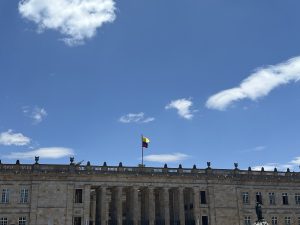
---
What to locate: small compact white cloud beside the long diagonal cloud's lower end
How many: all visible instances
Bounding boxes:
[165,98,194,120]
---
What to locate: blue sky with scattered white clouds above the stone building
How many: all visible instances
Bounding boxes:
[0,0,300,171]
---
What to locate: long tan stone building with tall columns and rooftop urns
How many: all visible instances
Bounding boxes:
[0,161,300,225]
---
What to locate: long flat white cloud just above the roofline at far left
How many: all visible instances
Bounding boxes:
[2,147,74,159]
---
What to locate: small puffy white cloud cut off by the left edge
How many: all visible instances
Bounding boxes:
[0,130,31,146]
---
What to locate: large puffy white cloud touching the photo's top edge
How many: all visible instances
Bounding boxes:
[19,0,116,46]
